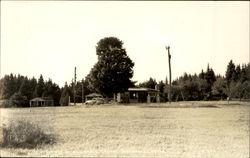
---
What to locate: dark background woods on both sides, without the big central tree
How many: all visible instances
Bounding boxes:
[0,60,250,107]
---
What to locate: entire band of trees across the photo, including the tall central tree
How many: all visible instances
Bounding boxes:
[0,37,250,106]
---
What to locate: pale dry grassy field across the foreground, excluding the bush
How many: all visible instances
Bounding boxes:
[0,102,250,158]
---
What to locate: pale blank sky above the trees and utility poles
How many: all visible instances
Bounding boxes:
[1,1,249,86]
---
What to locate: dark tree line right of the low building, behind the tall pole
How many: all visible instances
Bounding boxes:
[137,60,250,101]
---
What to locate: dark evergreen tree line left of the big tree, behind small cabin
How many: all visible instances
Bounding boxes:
[0,73,94,107]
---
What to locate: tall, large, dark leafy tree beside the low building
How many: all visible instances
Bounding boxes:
[86,37,134,96]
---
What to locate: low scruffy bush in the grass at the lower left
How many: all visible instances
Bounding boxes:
[1,121,55,148]
